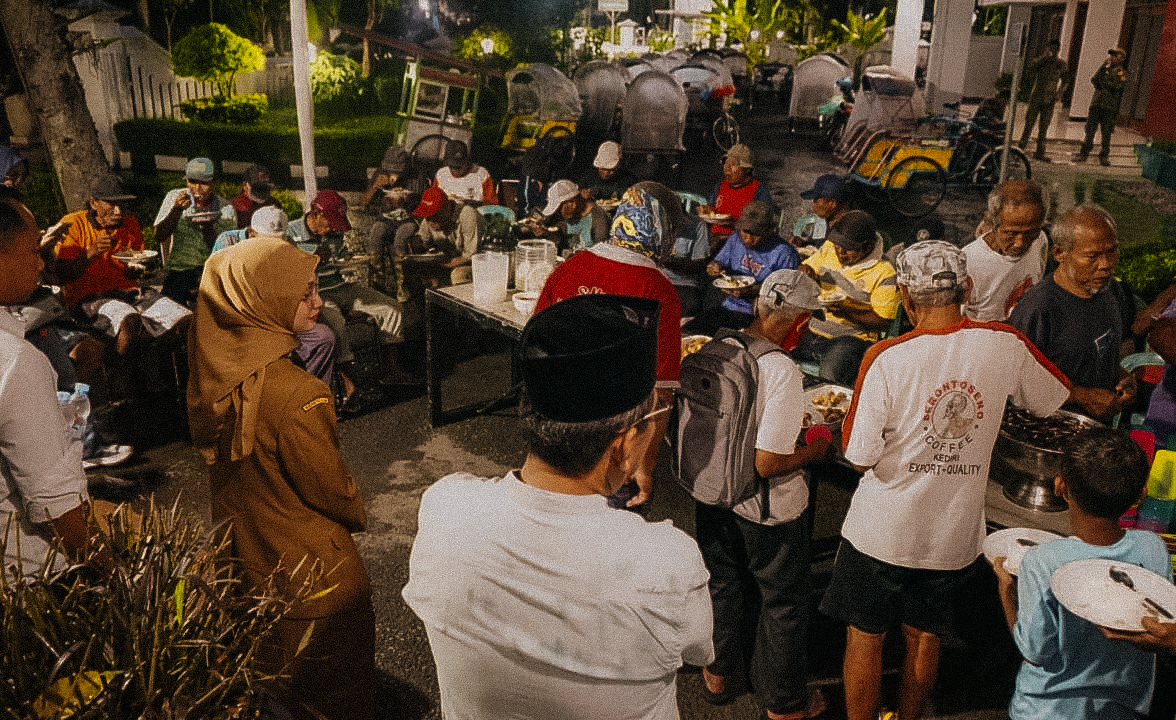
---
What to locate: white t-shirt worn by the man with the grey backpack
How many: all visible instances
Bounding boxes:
[728,340,808,525]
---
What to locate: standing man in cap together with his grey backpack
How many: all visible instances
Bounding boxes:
[675,269,831,720]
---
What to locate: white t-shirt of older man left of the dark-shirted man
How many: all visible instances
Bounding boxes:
[963,233,1049,322]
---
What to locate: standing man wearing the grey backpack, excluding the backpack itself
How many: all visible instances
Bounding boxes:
[695,269,829,720]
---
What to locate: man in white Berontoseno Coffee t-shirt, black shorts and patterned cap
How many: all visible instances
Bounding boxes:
[821,241,1070,720]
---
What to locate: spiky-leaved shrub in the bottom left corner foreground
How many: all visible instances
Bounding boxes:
[0,502,322,720]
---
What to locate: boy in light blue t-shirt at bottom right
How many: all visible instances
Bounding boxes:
[994,428,1171,720]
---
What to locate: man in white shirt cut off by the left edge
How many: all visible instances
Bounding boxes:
[0,198,89,576]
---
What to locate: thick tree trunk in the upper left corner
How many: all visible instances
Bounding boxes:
[0,0,111,211]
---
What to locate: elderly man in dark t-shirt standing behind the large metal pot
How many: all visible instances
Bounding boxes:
[1009,205,1136,420]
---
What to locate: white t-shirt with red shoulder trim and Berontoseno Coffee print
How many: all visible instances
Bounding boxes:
[841,320,1069,571]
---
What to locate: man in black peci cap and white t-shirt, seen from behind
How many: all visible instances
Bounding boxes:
[403,295,714,720]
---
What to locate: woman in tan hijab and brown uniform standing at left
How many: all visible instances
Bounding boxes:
[188,238,375,720]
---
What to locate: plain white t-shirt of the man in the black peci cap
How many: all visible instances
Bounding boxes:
[403,473,714,720]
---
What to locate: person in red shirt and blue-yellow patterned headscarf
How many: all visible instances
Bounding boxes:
[535,189,682,507]
